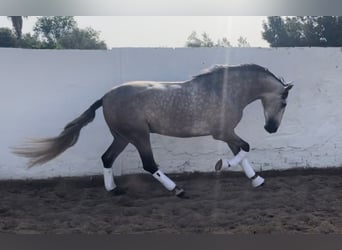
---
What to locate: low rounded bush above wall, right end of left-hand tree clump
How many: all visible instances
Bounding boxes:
[58,28,107,49]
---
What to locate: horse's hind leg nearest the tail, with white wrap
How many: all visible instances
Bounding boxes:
[101,136,128,195]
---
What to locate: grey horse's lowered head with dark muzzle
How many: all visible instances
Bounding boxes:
[261,83,293,133]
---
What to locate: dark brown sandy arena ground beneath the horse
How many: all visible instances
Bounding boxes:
[0,168,342,234]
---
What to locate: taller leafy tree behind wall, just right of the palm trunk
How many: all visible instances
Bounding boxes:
[33,16,76,48]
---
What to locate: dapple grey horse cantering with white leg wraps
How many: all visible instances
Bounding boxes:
[14,64,293,197]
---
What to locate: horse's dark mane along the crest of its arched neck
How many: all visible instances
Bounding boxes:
[193,64,285,85]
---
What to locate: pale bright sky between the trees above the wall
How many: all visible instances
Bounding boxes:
[0,16,268,48]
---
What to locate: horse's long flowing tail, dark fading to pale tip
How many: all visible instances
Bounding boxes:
[13,99,102,167]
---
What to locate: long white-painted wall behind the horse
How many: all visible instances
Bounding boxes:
[0,48,342,179]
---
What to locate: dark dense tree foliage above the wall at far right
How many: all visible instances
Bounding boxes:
[262,16,342,47]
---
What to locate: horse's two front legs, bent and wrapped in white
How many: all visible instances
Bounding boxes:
[215,134,265,187]
